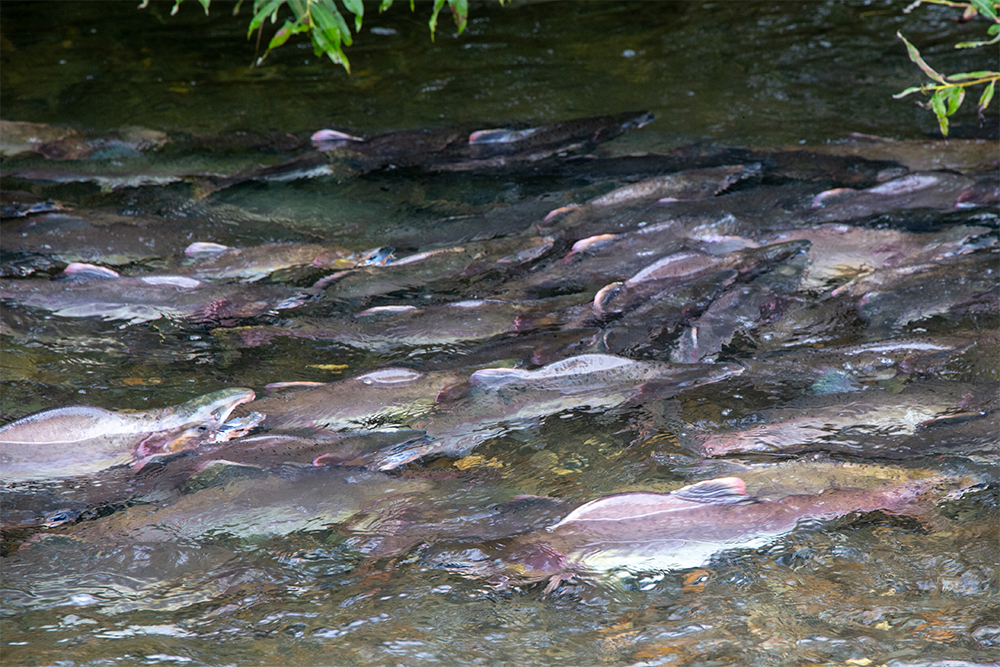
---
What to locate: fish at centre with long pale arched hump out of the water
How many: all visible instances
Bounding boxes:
[357,354,743,470]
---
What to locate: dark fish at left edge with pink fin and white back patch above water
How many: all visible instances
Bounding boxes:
[0,262,316,325]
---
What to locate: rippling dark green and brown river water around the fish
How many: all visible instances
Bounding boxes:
[0,0,1000,666]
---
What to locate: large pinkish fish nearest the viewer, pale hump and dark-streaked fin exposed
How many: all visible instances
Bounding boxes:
[437,475,954,592]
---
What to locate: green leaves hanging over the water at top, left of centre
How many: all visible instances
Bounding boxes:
[146,0,504,73]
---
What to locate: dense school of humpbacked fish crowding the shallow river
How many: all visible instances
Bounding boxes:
[0,113,1000,593]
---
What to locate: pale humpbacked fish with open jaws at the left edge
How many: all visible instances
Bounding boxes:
[0,388,254,484]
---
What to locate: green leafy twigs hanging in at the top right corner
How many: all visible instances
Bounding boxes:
[893,0,1000,137]
